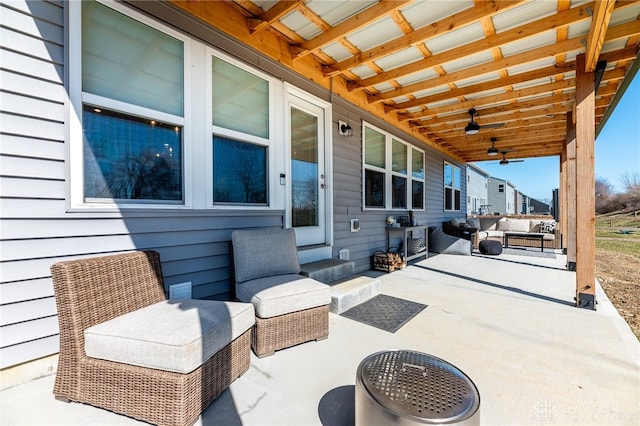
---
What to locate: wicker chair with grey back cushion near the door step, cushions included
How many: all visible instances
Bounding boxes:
[231,228,331,357]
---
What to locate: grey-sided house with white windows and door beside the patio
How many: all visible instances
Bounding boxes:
[0,1,470,376]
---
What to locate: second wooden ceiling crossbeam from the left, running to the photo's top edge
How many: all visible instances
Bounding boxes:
[290,0,413,60]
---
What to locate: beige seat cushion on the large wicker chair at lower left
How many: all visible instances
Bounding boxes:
[84,299,255,373]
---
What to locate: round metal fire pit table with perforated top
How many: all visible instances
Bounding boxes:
[355,350,480,426]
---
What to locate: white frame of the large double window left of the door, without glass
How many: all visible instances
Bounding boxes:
[65,0,285,212]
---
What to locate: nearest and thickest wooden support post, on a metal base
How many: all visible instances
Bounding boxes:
[576,54,596,310]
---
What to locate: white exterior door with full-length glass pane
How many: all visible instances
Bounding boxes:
[287,94,327,246]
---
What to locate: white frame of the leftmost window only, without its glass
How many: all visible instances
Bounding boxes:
[66,0,192,211]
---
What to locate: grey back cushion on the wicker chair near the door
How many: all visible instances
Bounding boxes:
[231,228,300,283]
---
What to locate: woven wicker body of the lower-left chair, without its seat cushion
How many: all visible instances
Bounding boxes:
[51,251,254,425]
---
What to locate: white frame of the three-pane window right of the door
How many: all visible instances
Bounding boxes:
[362,121,426,211]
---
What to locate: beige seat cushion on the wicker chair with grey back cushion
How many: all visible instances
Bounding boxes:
[236,274,331,318]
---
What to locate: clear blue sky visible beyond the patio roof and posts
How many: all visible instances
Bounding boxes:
[475,72,640,201]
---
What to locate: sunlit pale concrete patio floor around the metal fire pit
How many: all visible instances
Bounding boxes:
[0,254,640,426]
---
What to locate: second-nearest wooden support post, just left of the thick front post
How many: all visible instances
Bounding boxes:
[565,112,578,271]
